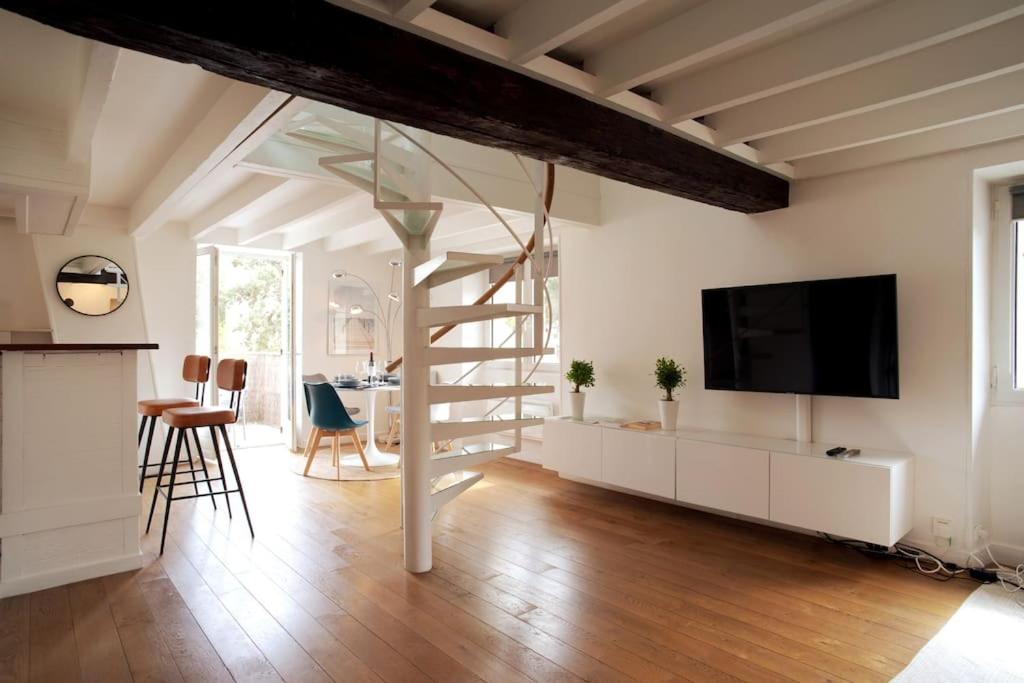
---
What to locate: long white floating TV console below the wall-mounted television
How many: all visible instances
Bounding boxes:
[544,418,913,546]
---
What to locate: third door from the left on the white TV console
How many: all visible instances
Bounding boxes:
[676,439,769,519]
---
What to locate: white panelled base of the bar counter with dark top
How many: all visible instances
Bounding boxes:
[0,349,142,597]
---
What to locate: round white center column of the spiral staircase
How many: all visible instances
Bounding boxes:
[401,234,433,573]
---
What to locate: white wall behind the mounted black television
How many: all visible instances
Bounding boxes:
[560,136,1024,548]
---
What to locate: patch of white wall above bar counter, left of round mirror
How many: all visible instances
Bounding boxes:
[0,228,53,331]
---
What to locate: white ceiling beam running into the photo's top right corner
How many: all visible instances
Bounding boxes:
[654,0,1024,123]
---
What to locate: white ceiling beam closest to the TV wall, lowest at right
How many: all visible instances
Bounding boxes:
[794,110,1024,178]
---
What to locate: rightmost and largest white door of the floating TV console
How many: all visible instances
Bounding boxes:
[771,453,899,546]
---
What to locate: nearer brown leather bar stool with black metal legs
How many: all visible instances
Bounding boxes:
[145,358,256,555]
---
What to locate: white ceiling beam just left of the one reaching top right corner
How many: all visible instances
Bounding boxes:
[584,0,852,96]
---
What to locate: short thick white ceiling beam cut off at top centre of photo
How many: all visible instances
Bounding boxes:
[495,0,644,65]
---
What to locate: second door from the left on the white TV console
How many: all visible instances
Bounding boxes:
[601,429,676,498]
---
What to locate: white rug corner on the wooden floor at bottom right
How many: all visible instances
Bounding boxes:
[893,584,1024,683]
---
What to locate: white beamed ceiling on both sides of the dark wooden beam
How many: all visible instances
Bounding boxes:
[8,0,1024,242]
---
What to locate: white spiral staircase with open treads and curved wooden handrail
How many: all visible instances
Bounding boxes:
[283,110,554,572]
